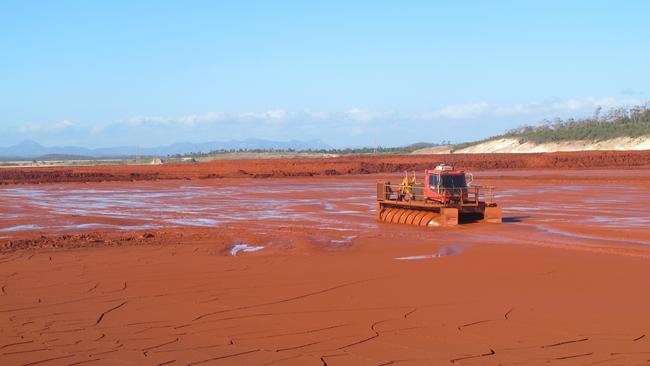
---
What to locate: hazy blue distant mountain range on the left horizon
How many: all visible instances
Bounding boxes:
[0,138,330,160]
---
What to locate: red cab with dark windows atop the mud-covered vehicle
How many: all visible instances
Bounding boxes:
[424,164,472,203]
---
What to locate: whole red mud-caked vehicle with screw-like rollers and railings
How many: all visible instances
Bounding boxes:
[377,164,501,226]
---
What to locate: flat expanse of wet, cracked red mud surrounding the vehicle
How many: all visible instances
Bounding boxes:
[0,164,650,365]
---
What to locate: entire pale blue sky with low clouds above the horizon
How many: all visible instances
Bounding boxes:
[0,0,650,147]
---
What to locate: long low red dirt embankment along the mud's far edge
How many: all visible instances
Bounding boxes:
[0,151,650,185]
